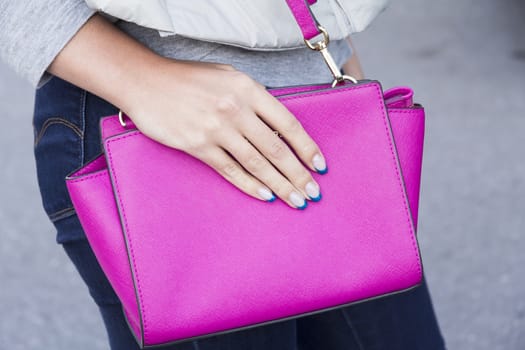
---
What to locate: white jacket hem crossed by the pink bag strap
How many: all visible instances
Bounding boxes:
[86,0,388,50]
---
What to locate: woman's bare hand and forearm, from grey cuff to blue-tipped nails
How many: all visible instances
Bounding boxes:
[49,15,326,209]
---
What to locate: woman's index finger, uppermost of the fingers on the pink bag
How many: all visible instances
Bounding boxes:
[252,89,327,174]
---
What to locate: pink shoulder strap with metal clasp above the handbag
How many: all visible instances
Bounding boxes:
[286,0,357,87]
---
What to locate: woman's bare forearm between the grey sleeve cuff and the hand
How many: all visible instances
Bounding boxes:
[48,15,170,110]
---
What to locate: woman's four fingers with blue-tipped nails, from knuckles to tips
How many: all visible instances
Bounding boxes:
[183,76,326,209]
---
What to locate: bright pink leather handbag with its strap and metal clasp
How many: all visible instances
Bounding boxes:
[66,0,424,348]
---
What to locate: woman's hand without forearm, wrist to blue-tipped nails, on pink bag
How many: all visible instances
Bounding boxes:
[124,60,324,208]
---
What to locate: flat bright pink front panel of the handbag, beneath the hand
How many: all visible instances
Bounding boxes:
[101,83,421,345]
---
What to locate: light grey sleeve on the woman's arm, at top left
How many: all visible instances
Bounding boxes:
[0,0,96,88]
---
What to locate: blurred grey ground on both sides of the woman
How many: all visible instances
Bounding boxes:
[0,0,525,350]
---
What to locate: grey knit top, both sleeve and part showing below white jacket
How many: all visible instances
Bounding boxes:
[0,0,352,88]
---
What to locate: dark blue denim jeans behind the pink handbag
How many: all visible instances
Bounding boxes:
[33,77,445,350]
